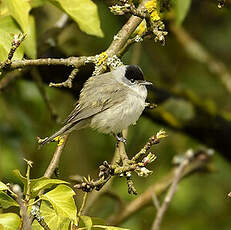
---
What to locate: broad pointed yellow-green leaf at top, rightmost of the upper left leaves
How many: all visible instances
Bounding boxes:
[50,0,104,37]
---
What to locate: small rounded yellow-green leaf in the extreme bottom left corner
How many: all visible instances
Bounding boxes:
[0,213,20,230]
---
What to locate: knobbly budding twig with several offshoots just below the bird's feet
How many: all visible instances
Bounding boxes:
[74,130,161,194]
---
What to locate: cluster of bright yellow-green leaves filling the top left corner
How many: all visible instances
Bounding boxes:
[0,0,103,61]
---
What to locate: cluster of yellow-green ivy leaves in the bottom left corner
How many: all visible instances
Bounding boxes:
[0,165,128,230]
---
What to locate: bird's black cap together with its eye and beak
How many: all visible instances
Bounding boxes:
[125,65,152,85]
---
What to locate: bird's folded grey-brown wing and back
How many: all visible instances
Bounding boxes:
[65,73,128,124]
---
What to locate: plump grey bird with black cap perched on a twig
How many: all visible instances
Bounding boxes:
[39,65,152,145]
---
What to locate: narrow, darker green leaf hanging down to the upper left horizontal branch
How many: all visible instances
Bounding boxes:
[23,16,37,59]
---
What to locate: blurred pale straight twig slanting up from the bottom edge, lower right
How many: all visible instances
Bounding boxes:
[151,150,193,230]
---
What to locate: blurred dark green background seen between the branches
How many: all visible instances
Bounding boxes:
[0,0,231,230]
